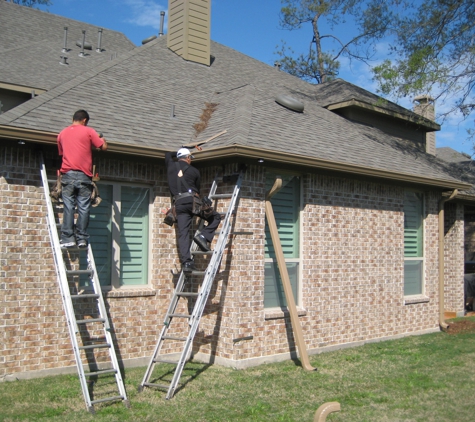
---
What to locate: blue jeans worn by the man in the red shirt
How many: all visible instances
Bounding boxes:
[61,170,92,243]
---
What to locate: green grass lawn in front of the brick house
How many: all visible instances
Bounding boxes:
[0,333,475,422]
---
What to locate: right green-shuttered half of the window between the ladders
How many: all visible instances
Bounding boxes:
[120,186,149,286]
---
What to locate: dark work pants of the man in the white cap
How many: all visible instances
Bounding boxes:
[175,197,221,264]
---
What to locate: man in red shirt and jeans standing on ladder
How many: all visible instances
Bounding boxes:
[58,110,107,248]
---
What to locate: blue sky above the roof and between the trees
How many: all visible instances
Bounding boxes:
[35,0,474,154]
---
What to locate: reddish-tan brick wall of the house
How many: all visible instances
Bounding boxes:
[0,145,463,377]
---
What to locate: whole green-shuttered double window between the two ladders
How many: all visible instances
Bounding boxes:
[81,183,150,288]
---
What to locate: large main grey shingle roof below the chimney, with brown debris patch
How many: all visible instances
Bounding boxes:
[0,3,468,189]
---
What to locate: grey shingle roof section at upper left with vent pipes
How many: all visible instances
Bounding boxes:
[0,0,135,90]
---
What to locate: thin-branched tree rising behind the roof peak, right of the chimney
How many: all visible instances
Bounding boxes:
[276,0,391,83]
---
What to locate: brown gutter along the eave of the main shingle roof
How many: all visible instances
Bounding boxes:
[0,125,472,190]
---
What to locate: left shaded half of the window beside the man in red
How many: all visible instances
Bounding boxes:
[81,184,112,286]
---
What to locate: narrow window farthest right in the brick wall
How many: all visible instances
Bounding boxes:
[404,191,424,296]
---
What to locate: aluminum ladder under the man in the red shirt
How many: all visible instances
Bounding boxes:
[40,155,130,414]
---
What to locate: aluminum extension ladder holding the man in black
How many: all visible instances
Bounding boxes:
[138,169,244,399]
